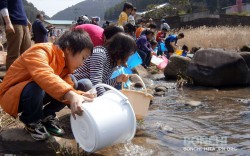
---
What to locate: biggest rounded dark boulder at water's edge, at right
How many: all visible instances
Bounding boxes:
[187,49,249,87]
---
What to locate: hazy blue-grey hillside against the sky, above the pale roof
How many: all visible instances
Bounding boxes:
[52,0,122,20]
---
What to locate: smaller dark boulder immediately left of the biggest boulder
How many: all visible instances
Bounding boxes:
[164,55,191,79]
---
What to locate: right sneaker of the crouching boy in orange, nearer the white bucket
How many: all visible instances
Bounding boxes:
[42,115,65,136]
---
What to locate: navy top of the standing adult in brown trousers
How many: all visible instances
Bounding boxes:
[0,0,28,26]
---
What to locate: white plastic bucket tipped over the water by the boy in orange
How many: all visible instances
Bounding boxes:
[71,84,136,152]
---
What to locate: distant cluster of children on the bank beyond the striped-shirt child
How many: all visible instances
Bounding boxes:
[117,2,188,68]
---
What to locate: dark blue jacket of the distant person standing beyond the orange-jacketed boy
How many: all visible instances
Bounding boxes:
[32,19,48,43]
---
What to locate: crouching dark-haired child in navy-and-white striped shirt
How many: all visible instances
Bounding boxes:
[73,33,136,96]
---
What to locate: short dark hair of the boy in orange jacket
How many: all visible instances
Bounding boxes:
[54,29,93,56]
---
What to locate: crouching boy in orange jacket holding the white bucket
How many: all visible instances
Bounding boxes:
[0,30,94,140]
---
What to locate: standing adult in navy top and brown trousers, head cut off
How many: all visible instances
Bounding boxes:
[0,0,31,70]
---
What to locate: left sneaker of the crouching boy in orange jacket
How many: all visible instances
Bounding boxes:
[25,121,50,141]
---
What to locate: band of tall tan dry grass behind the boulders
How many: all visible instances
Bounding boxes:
[176,26,250,51]
